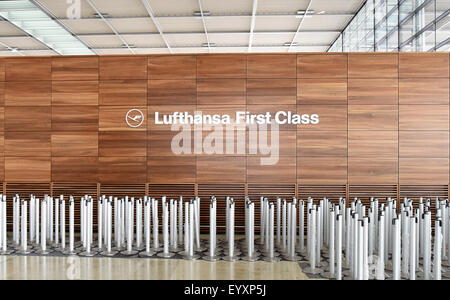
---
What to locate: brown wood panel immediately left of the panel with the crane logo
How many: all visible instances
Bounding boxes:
[52,105,98,131]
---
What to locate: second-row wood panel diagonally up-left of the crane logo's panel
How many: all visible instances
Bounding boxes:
[52,81,98,105]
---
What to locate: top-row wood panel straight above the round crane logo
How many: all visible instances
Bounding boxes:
[99,56,147,80]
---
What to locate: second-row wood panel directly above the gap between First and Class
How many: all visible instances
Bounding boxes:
[247,79,297,104]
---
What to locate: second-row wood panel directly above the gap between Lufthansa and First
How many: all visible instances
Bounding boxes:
[197,79,246,105]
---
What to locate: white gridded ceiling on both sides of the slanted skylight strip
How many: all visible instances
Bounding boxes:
[0,0,365,56]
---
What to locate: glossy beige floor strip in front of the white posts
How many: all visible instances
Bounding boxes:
[0,256,308,280]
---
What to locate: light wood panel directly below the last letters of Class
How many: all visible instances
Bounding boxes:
[297,131,347,156]
